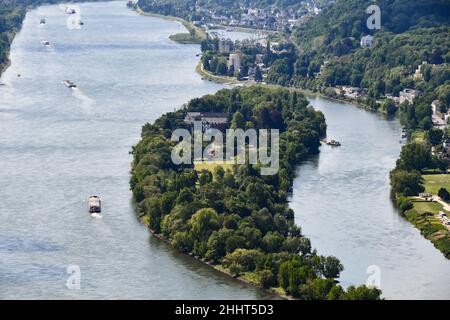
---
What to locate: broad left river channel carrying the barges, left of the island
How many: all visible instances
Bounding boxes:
[0,2,271,299]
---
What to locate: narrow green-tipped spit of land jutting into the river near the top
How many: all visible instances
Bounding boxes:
[134,5,206,44]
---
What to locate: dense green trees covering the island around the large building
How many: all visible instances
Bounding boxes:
[130,86,380,299]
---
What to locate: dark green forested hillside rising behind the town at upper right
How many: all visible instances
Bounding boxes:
[293,0,450,98]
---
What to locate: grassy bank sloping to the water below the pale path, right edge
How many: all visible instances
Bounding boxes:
[404,199,450,259]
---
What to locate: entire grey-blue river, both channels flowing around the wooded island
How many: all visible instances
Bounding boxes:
[0,2,450,299]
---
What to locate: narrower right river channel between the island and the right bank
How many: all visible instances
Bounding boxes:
[291,97,450,299]
